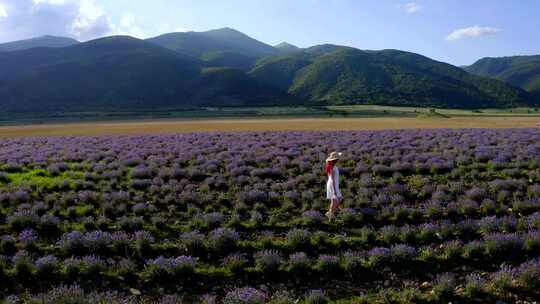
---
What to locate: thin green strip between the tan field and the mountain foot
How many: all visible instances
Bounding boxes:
[4,105,540,126]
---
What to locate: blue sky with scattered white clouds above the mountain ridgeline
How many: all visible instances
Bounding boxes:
[0,0,540,65]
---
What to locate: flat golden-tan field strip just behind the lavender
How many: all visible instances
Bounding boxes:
[0,115,540,137]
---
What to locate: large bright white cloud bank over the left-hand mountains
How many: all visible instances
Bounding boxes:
[0,0,190,42]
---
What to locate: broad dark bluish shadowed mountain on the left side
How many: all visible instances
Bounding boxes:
[0,36,296,111]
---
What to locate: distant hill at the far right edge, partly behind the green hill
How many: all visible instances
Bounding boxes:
[464,55,540,96]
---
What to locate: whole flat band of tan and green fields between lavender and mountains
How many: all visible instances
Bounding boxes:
[0,105,540,137]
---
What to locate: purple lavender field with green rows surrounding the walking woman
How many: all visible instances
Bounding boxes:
[0,129,540,304]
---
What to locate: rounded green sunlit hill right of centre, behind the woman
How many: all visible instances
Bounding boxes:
[250,45,530,108]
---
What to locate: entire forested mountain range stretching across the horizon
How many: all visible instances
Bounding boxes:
[0,28,539,112]
